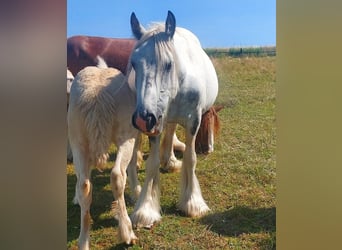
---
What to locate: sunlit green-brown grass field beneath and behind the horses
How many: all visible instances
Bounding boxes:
[67,54,276,249]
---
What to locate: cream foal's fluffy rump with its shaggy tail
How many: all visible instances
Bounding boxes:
[68,66,135,155]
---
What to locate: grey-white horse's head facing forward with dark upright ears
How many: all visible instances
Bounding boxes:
[130,11,178,135]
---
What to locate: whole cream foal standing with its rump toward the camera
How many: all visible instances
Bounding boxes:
[68,67,140,249]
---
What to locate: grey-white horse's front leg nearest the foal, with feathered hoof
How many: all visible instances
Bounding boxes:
[131,135,161,228]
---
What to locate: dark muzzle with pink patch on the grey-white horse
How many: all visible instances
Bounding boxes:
[132,111,160,136]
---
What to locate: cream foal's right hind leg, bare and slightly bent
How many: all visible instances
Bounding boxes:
[110,139,138,244]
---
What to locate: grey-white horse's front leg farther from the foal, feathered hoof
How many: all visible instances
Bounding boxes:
[179,115,210,217]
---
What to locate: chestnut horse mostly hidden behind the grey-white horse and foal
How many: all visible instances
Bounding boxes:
[67,36,219,155]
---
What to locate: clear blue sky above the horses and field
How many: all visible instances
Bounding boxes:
[67,0,276,48]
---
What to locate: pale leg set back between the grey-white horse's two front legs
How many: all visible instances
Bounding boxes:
[160,123,185,172]
